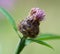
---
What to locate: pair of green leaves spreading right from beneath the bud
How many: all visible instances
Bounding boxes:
[28,34,60,49]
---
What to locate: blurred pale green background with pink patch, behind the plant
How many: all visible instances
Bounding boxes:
[0,0,60,54]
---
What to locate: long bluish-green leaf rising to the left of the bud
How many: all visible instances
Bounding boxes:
[0,7,21,38]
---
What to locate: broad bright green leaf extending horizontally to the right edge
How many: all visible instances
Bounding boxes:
[36,34,60,40]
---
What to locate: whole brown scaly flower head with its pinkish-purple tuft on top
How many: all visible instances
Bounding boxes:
[18,8,45,38]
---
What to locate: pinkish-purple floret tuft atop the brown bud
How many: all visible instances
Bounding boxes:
[30,8,45,21]
